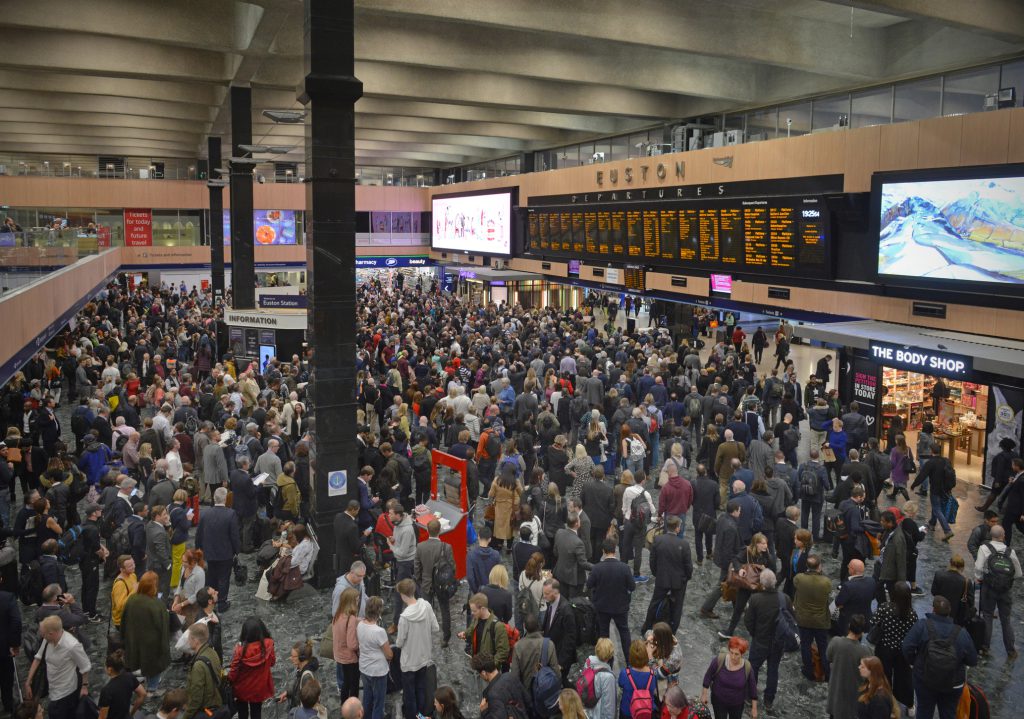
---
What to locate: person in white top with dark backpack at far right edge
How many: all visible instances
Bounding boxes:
[974,524,1022,660]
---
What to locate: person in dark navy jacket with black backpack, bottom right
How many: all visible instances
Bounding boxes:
[901,597,978,719]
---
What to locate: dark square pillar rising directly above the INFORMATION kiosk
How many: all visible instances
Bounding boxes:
[230,86,256,309]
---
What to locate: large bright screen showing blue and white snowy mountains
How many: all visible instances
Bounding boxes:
[879,177,1024,284]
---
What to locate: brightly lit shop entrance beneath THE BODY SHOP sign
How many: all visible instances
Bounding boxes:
[882,367,989,484]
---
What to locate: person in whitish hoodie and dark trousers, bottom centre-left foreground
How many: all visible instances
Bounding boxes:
[394,578,440,719]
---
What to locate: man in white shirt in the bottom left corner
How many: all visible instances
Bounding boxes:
[24,615,92,719]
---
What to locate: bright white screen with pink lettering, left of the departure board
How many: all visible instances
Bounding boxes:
[430,187,516,257]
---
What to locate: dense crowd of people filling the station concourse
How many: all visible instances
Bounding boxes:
[0,281,1024,719]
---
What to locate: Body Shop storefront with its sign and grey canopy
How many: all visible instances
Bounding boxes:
[805,322,1024,484]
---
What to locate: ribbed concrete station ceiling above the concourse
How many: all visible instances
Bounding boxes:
[0,0,1024,167]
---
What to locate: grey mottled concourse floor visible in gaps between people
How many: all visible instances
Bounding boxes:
[22,305,1024,719]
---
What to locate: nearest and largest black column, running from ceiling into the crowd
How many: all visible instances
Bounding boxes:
[300,0,362,585]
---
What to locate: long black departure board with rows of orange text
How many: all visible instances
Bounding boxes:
[527,197,830,278]
